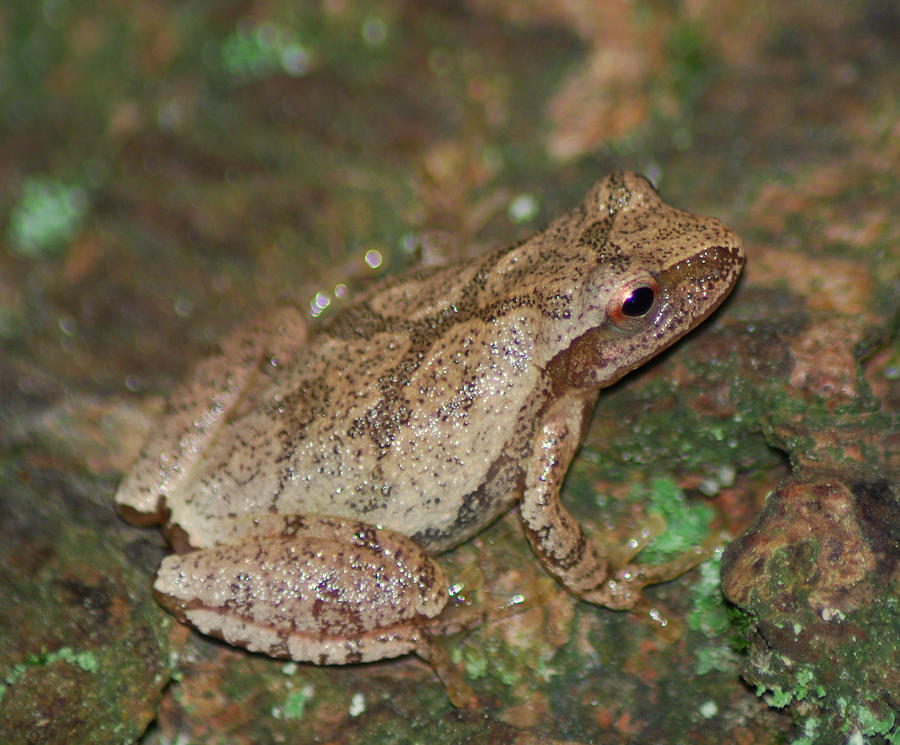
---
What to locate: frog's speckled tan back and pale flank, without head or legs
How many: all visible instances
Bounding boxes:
[179,247,568,550]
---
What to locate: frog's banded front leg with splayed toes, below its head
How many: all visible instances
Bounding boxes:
[520,396,704,610]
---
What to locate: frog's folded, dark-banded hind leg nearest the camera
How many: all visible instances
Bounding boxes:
[154,515,447,664]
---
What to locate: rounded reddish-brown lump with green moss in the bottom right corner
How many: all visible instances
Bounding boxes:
[722,472,900,743]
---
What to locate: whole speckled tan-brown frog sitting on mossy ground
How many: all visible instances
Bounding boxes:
[115,172,745,706]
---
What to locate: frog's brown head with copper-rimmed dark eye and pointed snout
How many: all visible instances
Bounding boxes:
[549,173,744,389]
